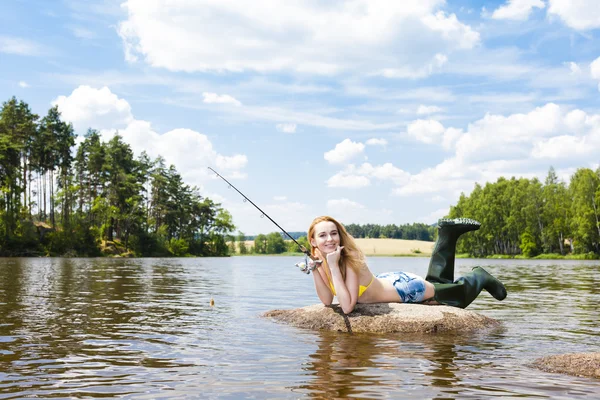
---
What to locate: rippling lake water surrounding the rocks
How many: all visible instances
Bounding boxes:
[0,257,600,399]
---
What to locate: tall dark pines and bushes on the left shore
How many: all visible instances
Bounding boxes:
[0,97,235,256]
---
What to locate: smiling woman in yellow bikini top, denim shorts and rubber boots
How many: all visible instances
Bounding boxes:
[308,216,506,314]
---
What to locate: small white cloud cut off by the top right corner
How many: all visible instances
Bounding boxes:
[548,0,600,31]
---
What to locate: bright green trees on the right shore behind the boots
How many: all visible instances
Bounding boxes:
[449,167,600,258]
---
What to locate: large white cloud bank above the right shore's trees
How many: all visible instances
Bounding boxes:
[393,103,600,199]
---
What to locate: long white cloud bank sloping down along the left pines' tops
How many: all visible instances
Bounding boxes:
[53,86,248,184]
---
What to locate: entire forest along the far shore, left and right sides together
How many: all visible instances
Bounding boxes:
[0,97,600,258]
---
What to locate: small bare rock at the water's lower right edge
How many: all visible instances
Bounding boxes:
[531,352,600,379]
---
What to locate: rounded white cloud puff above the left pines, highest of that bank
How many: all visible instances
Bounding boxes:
[52,85,133,133]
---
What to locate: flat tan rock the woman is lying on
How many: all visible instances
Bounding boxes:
[263,303,499,333]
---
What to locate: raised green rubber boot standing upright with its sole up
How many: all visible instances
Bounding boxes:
[425,218,481,283]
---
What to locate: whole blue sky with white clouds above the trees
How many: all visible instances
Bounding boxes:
[0,0,600,235]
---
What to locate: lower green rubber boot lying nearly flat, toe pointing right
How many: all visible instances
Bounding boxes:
[433,267,507,308]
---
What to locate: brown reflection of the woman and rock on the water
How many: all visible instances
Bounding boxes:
[299,332,502,399]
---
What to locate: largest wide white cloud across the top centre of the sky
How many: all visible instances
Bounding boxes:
[118,0,480,75]
